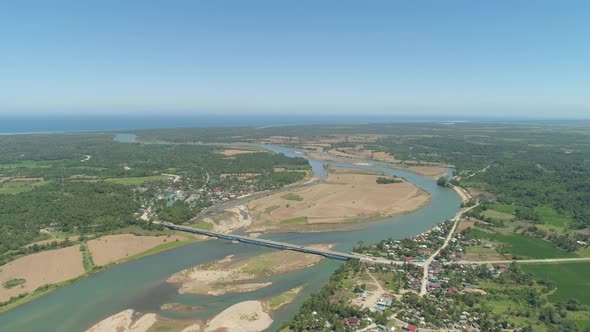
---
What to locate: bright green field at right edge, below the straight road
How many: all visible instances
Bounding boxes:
[521,262,590,306]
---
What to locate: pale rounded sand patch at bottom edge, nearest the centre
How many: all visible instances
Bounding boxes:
[205,301,273,332]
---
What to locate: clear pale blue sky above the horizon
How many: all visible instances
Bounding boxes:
[0,0,590,118]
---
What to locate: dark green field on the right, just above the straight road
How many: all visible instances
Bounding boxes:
[478,228,578,259]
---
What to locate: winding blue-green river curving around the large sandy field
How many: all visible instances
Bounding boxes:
[0,137,460,331]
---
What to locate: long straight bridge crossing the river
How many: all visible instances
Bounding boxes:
[162,222,402,264]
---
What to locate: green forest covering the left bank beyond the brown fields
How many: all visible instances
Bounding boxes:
[0,133,309,265]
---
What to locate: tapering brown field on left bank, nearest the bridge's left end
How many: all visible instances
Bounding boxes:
[88,234,185,266]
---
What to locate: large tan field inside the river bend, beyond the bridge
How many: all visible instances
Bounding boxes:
[248,168,430,231]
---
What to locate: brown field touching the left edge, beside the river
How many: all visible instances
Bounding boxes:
[0,245,85,302]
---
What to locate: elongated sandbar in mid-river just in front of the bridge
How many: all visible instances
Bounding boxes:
[168,245,332,296]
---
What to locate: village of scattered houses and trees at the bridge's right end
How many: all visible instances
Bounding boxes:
[328,217,526,331]
